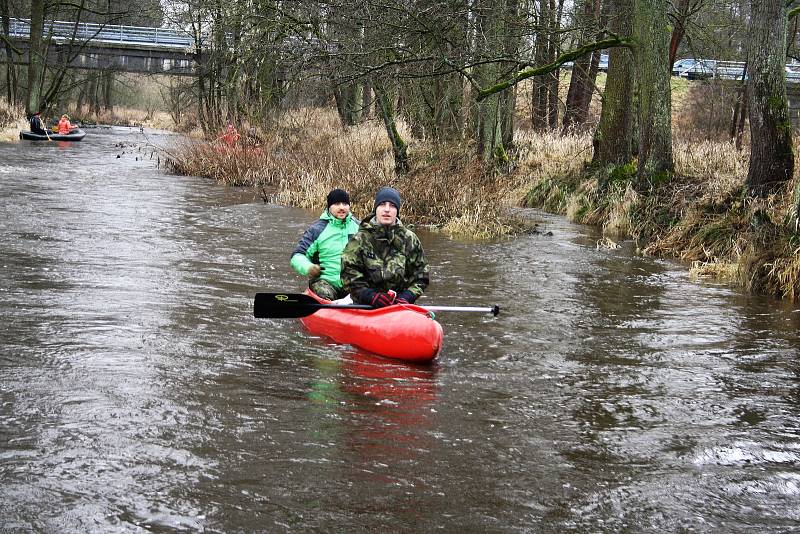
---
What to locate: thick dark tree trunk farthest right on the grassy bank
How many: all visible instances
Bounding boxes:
[746,0,794,197]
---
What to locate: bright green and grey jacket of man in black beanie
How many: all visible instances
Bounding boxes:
[291,210,358,288]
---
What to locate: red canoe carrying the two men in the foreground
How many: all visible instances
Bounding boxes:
[300,290,443,363]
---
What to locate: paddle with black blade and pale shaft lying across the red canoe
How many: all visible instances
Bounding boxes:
[253,293,500,319]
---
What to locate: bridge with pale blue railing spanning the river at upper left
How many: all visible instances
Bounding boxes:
[0,18,200,76]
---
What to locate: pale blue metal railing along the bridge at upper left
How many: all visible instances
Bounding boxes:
[9,18,195,48]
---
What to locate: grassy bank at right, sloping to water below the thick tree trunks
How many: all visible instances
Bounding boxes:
[524,142,800,300]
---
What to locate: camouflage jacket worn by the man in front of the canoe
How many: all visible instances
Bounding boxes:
[342,217,429,302]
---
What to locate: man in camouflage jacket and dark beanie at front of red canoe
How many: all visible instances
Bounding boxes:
[342,187,429,308]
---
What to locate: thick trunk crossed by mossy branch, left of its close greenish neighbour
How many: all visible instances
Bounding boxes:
[592,0,636,167]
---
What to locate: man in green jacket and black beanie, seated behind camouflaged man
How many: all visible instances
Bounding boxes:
[291,189,358,300]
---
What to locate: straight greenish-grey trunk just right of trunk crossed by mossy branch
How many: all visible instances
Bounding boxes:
[634,0,674,185]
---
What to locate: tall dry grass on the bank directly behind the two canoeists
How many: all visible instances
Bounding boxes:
[167,109,536,238]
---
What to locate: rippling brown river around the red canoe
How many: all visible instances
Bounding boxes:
[0,128,800,532]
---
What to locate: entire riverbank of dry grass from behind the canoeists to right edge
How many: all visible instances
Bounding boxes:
[167,110,800,300]
